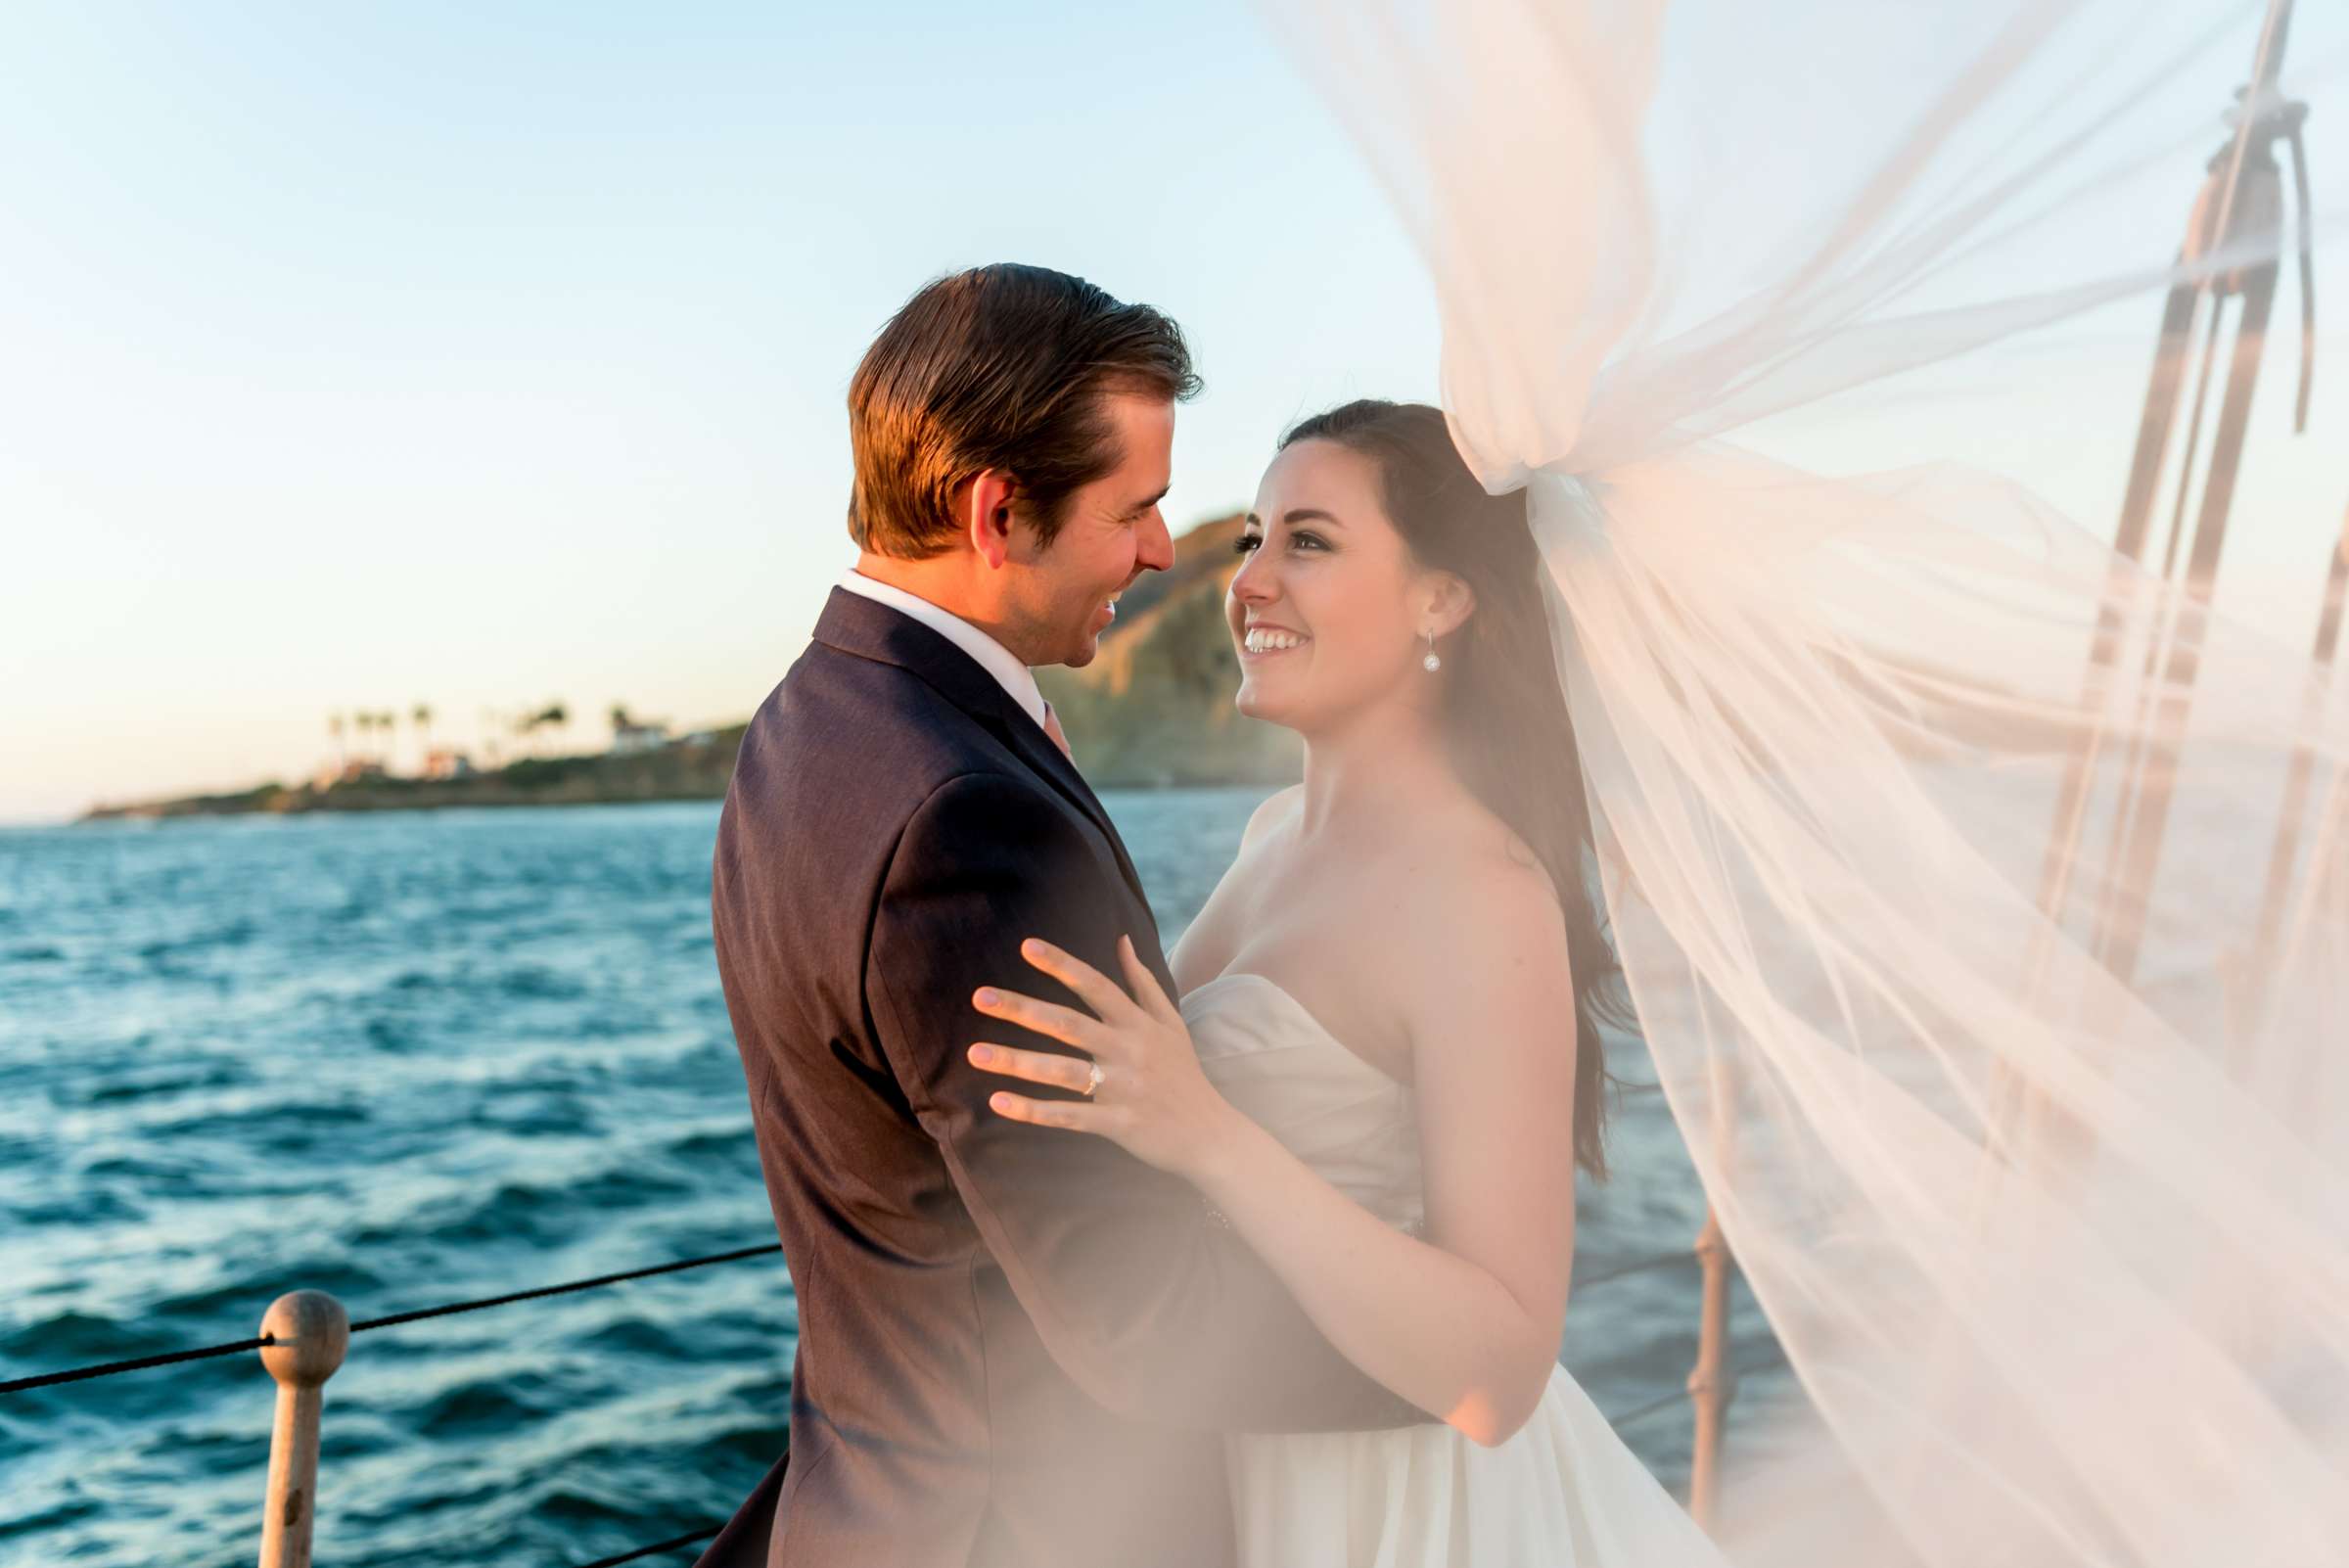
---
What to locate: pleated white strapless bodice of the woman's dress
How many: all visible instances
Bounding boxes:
[1181,974,1426,1230]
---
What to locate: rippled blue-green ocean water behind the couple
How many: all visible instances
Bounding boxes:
[0,791,1769,1568]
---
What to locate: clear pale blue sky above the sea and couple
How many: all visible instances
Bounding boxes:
[14,0,2349,819]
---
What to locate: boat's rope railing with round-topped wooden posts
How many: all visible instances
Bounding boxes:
[0,1239,1760,1568]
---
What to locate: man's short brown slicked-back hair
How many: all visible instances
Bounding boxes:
[848,263,1198,561]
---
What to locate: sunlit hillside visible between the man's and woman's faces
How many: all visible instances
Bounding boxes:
[1036,517,1302,789]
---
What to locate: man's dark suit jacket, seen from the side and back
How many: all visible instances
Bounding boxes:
[703,591,1426,1568]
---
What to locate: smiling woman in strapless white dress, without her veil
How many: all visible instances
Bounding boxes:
[973,401,1713,1568]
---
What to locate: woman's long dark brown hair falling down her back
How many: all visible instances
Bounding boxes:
[1280,399,1633,1176]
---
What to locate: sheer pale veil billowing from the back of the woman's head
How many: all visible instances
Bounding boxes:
[1273,0,2349,1568]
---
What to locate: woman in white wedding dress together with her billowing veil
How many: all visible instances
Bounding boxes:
[963,0,2349,1568]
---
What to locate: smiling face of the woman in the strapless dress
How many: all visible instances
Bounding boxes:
[1223,441,1440,735]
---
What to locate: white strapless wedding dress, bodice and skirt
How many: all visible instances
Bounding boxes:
[1181,974,1725,1568]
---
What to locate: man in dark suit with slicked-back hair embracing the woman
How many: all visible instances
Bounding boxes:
[703,265,1426,1568]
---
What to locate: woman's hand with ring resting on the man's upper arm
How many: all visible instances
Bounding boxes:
[970,937,1245,1180]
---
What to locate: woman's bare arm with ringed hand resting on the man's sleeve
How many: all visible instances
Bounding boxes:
[973,878,1574,1444]
